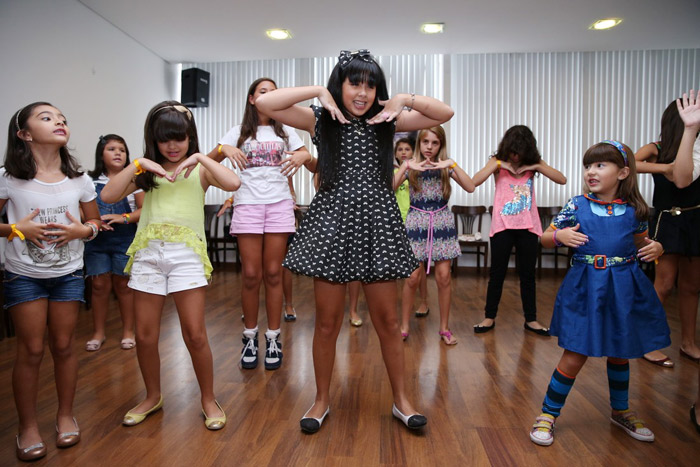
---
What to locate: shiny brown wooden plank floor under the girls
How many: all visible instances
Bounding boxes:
[0,269,700,466]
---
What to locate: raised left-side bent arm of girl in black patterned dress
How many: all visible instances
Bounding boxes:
[255,86,330,135]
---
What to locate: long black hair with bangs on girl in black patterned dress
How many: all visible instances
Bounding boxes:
[318,57,395,190]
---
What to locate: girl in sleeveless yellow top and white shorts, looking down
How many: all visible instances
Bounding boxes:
[102,101,241,430]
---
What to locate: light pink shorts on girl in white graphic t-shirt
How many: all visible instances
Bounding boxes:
[231,199,295,235]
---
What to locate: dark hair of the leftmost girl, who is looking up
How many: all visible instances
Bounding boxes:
[5,102,83,180]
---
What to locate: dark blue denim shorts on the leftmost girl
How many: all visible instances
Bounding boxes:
[3,269,85,309]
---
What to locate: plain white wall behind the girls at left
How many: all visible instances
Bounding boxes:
[0,0,178,169]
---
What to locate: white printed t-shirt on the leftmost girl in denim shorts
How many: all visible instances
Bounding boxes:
[0,168,97,279]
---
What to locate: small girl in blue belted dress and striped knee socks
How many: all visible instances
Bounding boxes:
[530,141,671,446]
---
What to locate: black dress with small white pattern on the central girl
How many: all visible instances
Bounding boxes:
[283,106,418,283]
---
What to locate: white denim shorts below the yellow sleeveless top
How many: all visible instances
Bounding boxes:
[129,240,208,295]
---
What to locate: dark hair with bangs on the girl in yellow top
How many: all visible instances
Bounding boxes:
[136,101,199,191]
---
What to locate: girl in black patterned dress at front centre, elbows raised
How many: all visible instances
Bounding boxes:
[256,50,453,433]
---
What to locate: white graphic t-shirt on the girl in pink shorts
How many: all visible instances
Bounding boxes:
[219,125,304,206]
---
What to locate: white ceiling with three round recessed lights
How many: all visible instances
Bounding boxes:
[79,0,700,63]
